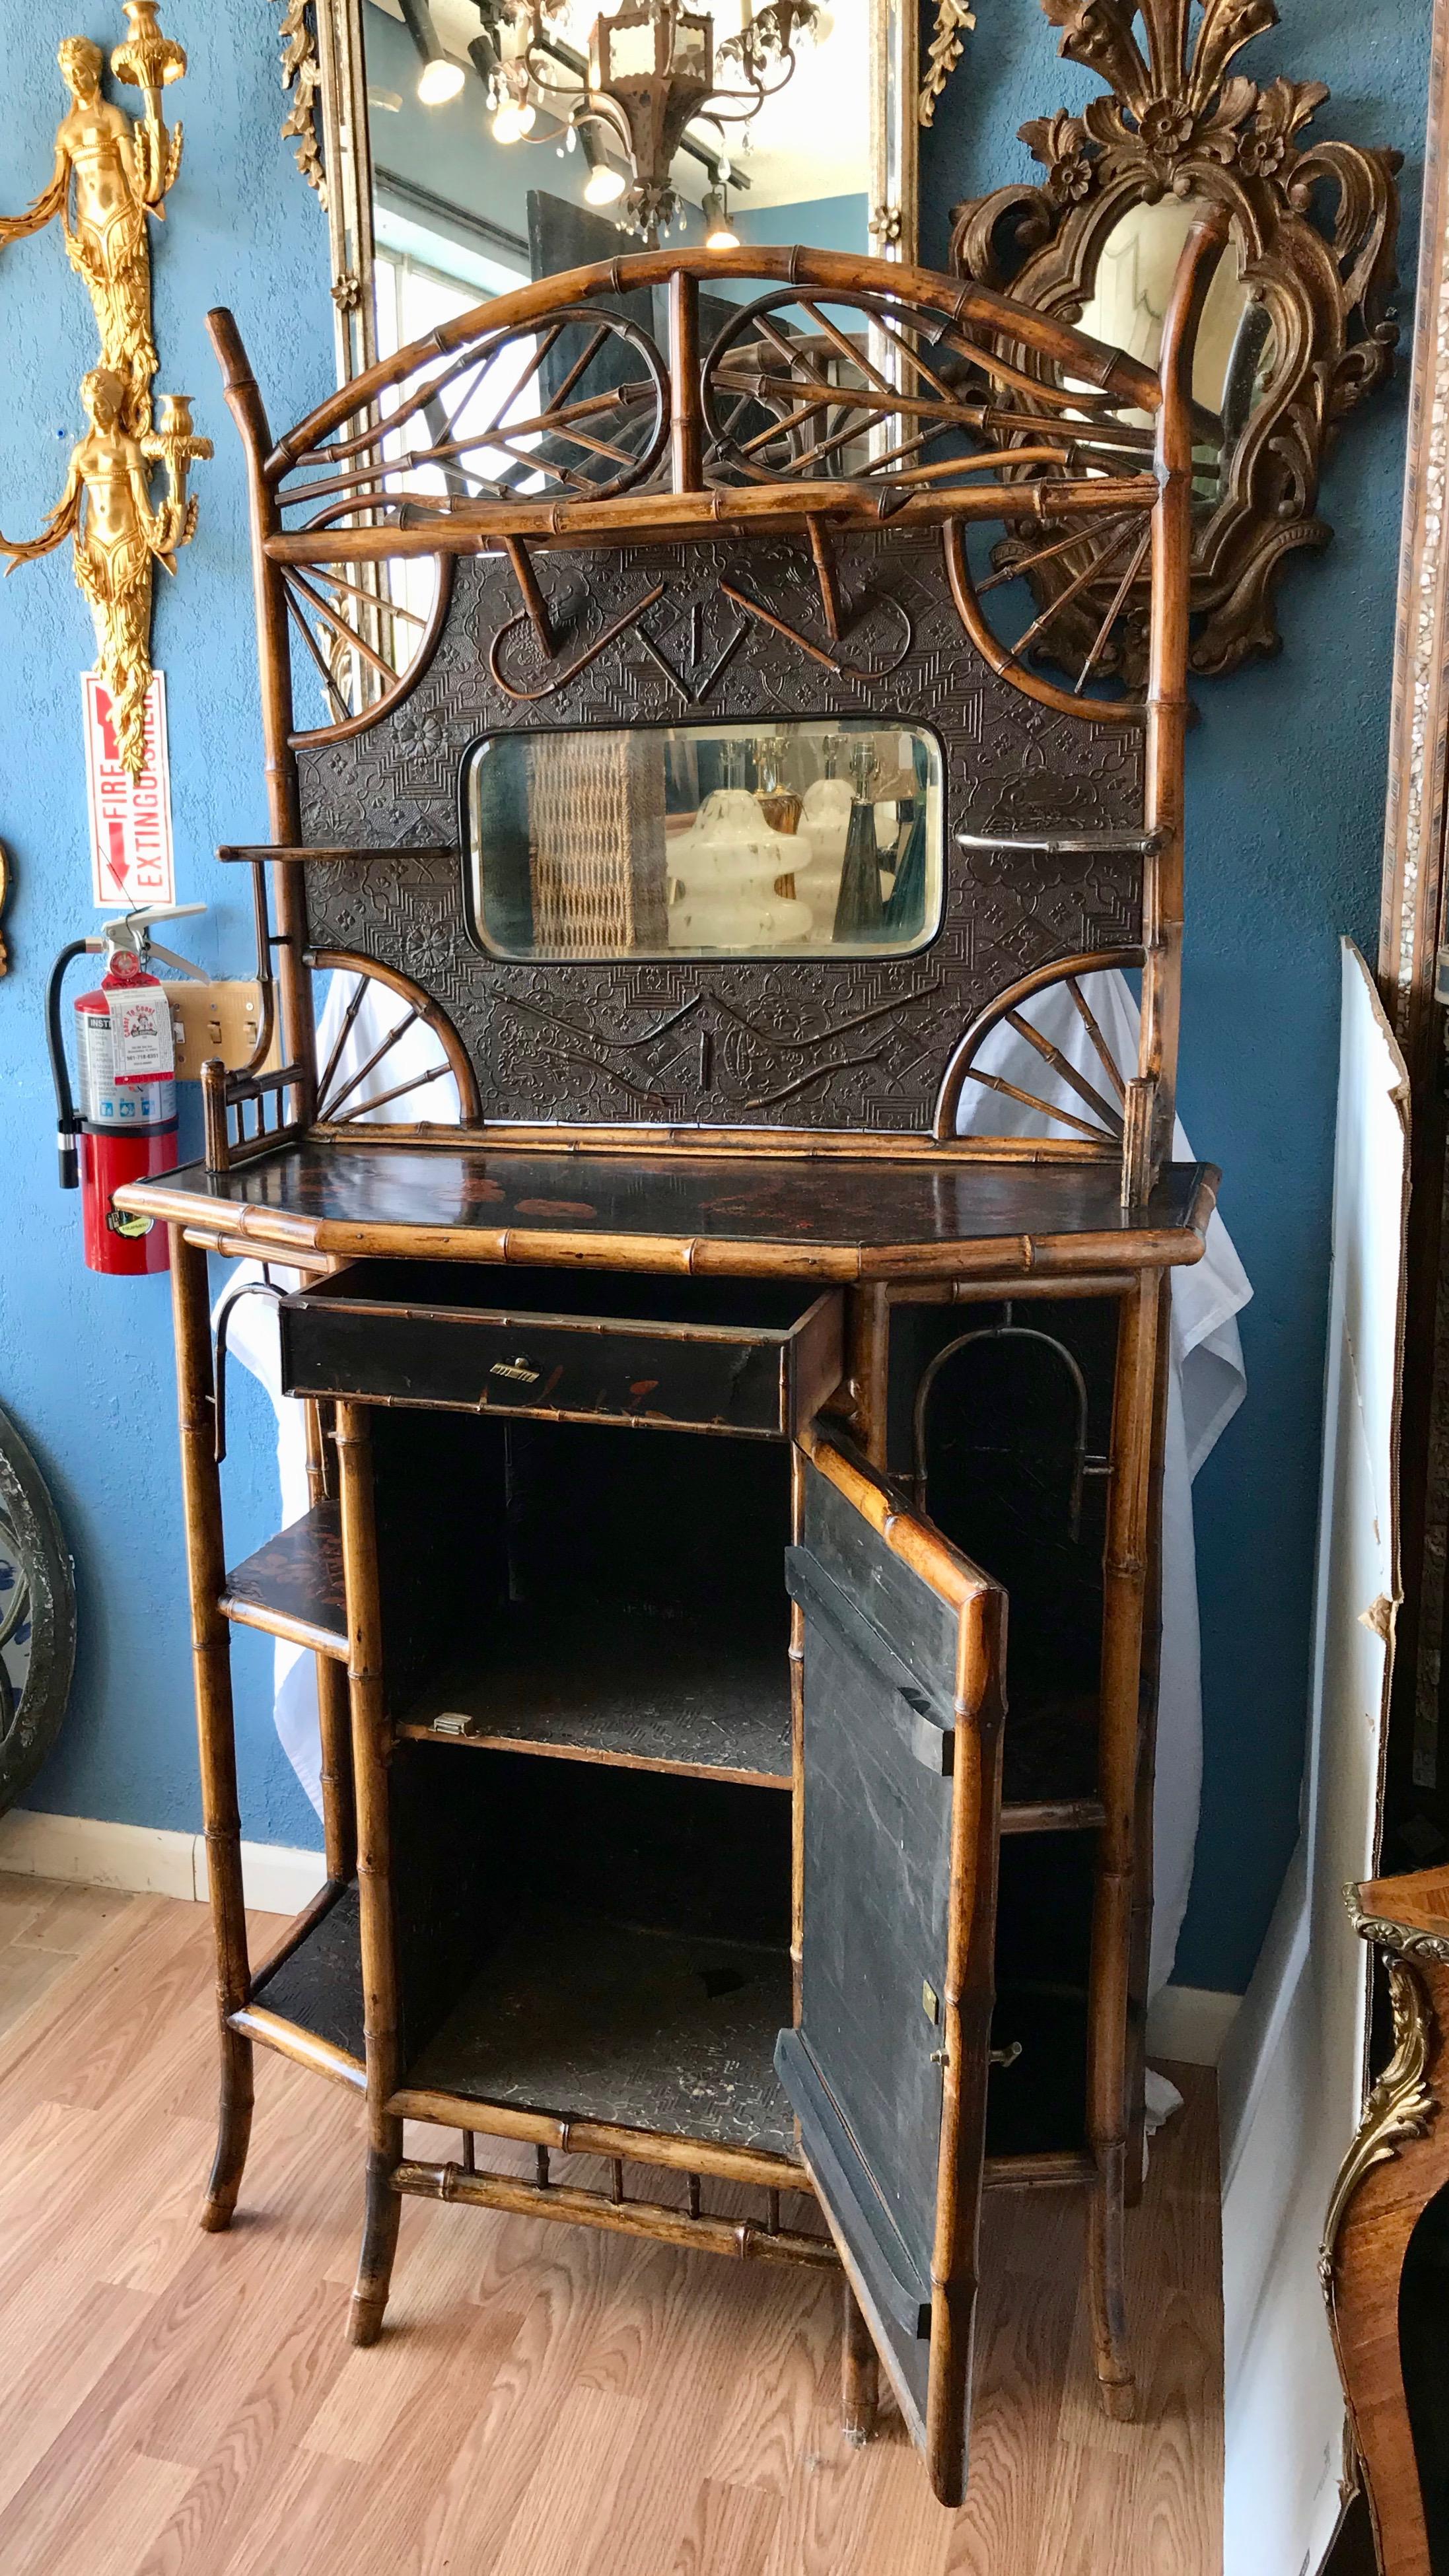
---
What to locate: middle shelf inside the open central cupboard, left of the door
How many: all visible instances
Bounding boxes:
[400,1602,792,1788]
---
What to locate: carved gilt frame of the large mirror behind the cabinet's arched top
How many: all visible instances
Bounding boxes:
[279,0,912,384]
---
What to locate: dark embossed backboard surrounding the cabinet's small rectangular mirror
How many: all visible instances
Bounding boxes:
[299,528,1142,1133]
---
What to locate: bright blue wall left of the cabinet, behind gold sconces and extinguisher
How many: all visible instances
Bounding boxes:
[0,0,333,1842]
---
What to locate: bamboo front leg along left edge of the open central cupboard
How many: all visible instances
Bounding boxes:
[337,1404,402,2344]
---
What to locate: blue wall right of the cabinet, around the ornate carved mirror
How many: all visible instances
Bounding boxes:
[921,0,1429,1989]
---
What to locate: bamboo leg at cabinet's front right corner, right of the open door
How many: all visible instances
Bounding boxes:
[1088,1272,1158,2419]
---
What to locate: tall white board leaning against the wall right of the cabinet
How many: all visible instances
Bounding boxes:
[1220,940,1408,2576]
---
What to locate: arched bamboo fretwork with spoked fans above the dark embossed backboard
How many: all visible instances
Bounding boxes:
[268,286,1155,742]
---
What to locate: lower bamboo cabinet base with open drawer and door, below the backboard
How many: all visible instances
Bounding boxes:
[149,1141,1215,2496]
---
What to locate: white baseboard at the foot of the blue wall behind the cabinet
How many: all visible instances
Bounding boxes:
[0,1806,1240,2066]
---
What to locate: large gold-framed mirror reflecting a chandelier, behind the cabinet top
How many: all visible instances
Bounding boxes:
[279,0,928,381]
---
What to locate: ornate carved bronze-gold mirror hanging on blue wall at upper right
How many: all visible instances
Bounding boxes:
[952,0,1403,680]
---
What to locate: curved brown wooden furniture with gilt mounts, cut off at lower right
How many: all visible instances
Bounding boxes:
[1320,1870,1449,2576]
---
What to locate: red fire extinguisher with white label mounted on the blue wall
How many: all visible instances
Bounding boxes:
[46,904,206,1278]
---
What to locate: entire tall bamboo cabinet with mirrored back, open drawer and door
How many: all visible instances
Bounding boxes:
[126,224,1222,2501]
